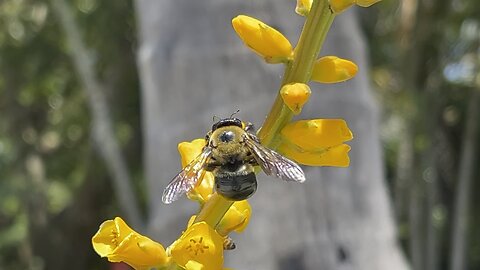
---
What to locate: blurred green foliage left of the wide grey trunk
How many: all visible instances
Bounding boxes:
[0,0,142,269]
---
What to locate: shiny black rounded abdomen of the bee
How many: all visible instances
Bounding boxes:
[215,164,257,201]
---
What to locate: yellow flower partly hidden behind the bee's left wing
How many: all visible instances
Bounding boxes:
[178,139,215,204]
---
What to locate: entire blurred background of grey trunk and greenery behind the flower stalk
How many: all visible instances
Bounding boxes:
[0,0,480,270]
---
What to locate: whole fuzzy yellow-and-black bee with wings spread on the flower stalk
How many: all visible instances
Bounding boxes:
[162,117,305,204]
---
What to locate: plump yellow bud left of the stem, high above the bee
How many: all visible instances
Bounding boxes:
[232,15,293,63]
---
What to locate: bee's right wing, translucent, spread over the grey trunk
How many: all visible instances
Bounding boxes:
[245,135,305,183]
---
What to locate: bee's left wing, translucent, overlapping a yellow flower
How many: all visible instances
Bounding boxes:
[162,147,212,204]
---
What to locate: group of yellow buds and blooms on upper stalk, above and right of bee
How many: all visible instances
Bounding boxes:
[232,4,364,167]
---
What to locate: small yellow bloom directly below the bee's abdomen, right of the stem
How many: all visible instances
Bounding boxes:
[216,200,252,236]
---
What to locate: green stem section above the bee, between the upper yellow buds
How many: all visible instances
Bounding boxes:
[258,0,335,148]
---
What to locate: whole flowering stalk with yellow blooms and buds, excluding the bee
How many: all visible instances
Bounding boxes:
[92,0,379,270]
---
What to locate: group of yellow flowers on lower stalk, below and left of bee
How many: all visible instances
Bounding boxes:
[92,139,251,270]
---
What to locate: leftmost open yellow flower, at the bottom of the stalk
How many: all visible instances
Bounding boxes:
[92,217,168,269]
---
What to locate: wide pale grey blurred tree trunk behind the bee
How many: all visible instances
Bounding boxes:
[137,0,408,270]
